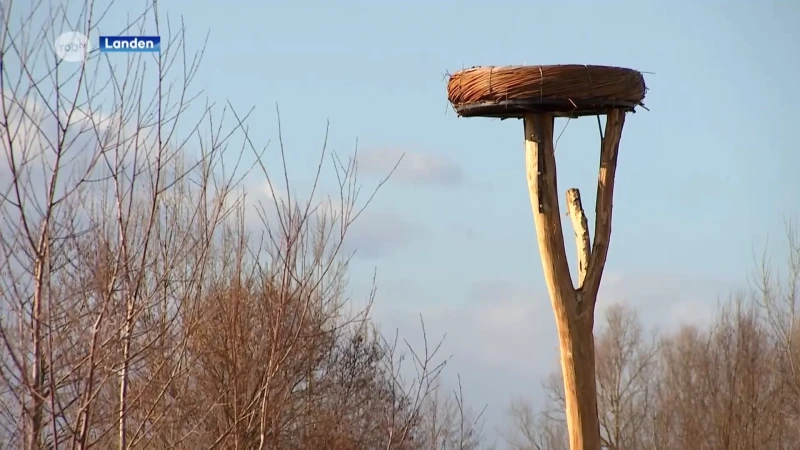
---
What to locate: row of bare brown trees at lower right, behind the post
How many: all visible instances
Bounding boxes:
[507,296,797,450]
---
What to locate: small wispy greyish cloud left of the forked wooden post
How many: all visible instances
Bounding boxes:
[358,149,464,186]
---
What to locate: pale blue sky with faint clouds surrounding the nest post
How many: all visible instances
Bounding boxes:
[21,0,800,442]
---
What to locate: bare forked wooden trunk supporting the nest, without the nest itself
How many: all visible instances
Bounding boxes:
[524,110,625,450]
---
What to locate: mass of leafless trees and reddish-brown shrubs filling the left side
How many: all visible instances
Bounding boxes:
[0,1,477,450]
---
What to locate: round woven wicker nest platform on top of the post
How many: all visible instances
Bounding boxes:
[447,64,647,118]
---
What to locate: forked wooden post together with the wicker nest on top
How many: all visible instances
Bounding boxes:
[448,65,646,450]
